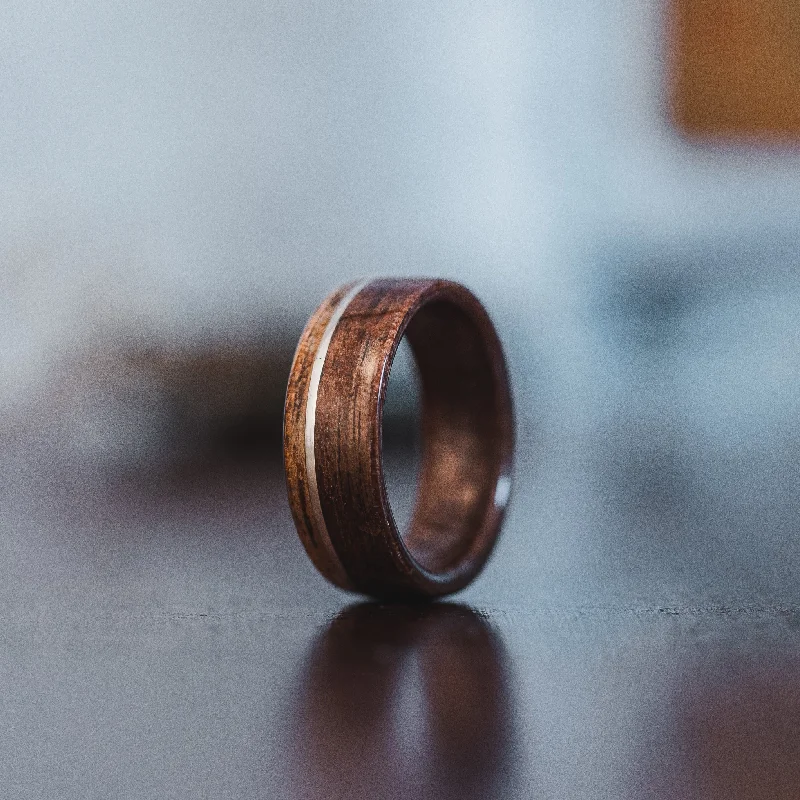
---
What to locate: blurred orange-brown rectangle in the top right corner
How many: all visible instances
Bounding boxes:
[668,0,800,139]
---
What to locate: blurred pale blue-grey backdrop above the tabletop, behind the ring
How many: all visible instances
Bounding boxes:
[0,0,800,476]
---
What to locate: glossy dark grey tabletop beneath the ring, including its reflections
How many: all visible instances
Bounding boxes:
[0,418,800,800]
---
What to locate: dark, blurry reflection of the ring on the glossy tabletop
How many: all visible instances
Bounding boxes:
[290,603,515,800]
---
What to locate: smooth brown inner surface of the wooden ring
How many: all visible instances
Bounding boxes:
[403,300,502,574]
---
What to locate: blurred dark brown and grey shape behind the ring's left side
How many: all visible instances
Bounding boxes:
[3,324,294,485]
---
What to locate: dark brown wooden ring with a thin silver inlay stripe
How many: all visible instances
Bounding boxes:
[284,279,514,598]
